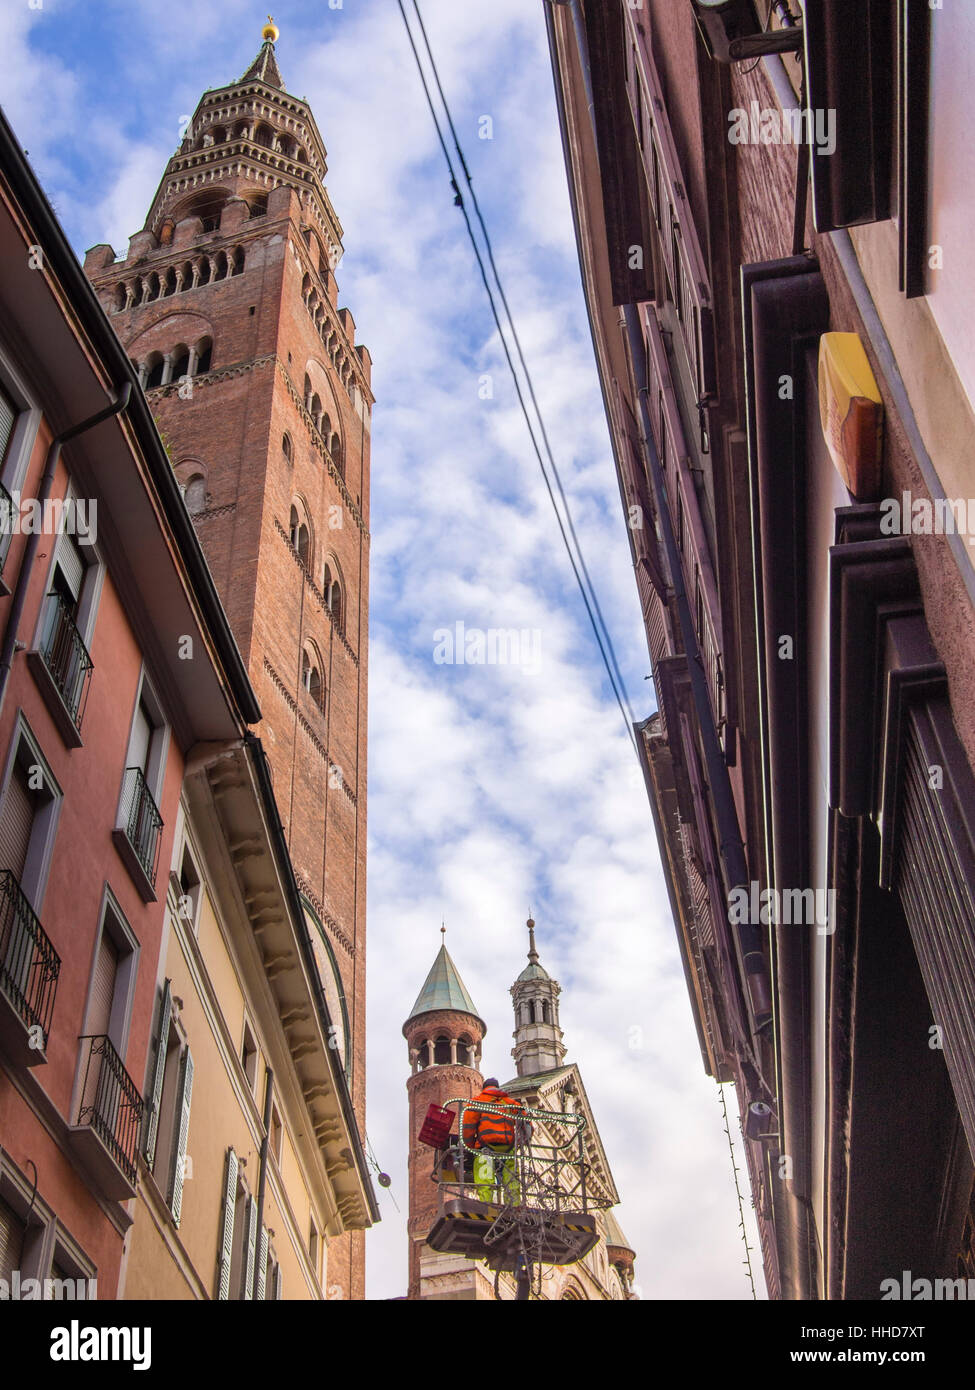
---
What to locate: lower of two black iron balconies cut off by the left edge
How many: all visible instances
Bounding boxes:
[0,869,61,1066]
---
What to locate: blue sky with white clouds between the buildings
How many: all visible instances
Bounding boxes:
[0,0,761,1298]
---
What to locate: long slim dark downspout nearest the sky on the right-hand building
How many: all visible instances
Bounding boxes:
[620,304,771,1024]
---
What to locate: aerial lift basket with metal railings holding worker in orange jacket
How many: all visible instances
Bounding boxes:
[420,1098,612,1298]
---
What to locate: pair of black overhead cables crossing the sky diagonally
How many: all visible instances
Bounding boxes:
[398,0,637,752]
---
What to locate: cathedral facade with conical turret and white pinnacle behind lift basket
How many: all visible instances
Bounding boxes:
[403,919,636,1301]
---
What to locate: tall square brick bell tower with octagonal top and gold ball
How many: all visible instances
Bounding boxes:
[85,24,373,1298]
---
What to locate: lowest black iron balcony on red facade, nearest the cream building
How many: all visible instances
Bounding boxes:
[68,1034,143,1201]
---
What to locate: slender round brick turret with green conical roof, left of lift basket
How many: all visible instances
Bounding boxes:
[403,927,484,1300]
